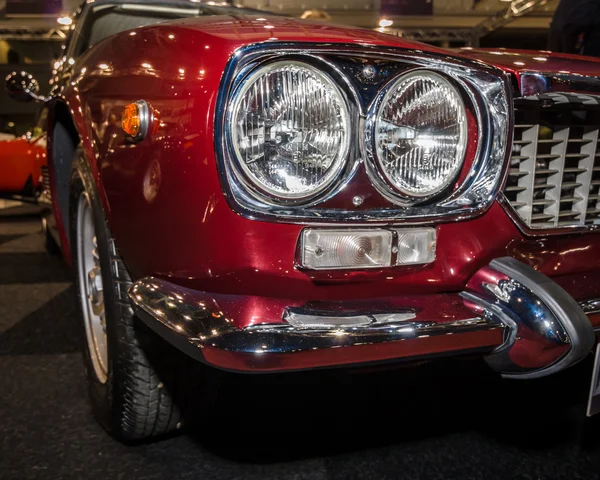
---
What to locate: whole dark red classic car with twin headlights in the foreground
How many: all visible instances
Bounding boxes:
[8,0,600,439]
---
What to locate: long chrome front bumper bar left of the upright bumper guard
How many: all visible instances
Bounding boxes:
[128,277,505,366]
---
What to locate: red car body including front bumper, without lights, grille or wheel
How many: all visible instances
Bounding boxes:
[15,10,600,373]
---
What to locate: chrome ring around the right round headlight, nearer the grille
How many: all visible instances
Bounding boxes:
[366,68,472,205]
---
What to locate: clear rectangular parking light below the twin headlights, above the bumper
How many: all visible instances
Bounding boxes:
[300,228,436,270]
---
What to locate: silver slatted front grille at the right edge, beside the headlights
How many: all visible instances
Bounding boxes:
[504,93,600,229]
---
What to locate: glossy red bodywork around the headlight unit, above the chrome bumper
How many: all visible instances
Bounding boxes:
[51,17,600,336]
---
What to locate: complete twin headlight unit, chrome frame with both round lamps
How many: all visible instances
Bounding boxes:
[215,46,512,226]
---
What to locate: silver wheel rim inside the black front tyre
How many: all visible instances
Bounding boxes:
[76,192,108,383]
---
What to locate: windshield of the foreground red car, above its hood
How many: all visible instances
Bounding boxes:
[76,2,264,55]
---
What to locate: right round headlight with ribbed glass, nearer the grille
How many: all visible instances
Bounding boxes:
[374,70,467,198]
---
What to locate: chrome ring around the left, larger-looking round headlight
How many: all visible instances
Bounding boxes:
[226,59,352,206]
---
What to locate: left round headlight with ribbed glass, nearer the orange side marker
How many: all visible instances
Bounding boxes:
[231,61,350,201]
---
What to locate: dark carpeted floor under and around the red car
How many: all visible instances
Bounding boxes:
[0,204,600,480]
